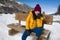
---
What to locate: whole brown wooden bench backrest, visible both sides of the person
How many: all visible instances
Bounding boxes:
[15,13,53,25]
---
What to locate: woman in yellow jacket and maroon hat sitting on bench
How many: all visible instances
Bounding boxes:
[22,4,44,40]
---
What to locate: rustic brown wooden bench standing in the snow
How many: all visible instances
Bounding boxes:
[7,13,53,40]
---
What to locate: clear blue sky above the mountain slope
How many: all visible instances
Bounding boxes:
[18,0,60,14]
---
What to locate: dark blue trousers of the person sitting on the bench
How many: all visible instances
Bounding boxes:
[22,28,43,40]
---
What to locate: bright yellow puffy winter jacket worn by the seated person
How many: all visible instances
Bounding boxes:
[26,11,44,30]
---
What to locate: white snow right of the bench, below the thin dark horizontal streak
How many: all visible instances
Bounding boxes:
[44,22,60,40]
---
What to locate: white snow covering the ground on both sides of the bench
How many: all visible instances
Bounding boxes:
[0,14,60,40]
